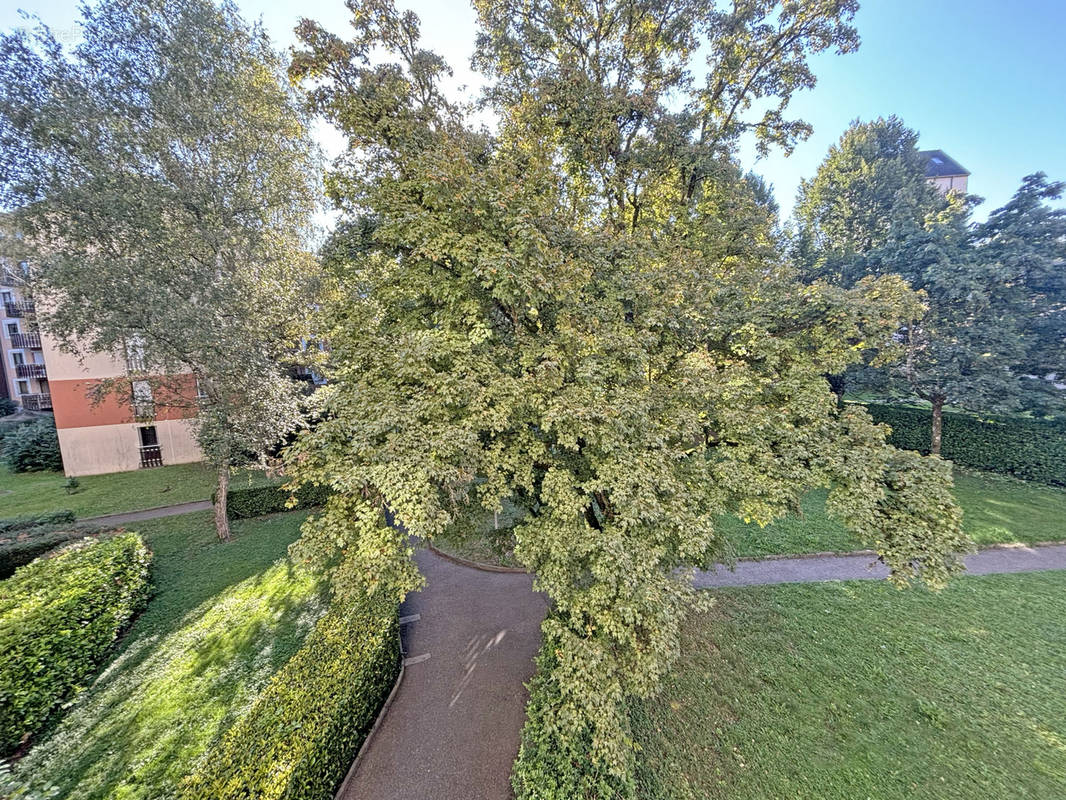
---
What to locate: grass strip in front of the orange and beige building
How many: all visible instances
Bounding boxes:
[0,464,279,517]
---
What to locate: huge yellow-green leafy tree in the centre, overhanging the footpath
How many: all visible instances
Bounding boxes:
[291,0,965,797]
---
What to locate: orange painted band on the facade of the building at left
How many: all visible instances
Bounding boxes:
[48,375,196,430]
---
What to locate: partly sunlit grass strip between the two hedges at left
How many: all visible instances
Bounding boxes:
[0,512,325,800]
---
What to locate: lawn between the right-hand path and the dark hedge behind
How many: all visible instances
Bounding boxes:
[720,471,1066,557]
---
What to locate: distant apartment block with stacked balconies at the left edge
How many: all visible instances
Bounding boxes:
[0,261,52,411]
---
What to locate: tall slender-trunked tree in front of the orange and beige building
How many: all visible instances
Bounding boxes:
[0,0,318,538]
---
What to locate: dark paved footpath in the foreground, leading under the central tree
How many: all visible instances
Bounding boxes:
[337,550,548,800]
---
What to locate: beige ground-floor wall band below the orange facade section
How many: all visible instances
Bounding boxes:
[57,420,204,476]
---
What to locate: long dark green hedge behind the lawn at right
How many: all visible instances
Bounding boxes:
[867,404,1066,486]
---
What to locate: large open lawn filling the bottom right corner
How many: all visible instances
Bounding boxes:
[633,572,1066,800]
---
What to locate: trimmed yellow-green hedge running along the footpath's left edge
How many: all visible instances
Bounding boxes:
[180,603,401,800]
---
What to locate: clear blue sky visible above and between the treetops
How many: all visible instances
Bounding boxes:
[0,0,1066,218]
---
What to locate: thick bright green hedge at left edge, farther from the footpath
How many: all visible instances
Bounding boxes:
[0,533,151,755]
